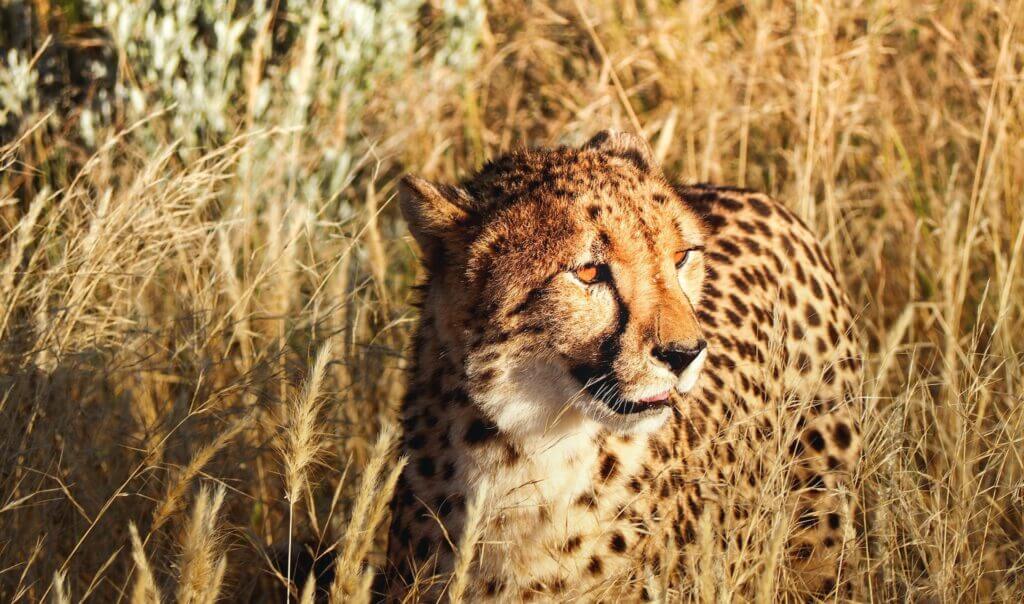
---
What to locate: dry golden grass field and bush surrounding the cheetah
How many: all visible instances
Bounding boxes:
[0,0,1024,602]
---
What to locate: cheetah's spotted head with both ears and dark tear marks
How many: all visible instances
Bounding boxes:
[401,132,707,433]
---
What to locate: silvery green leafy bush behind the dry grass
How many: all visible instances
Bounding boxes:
[72,0,484,157]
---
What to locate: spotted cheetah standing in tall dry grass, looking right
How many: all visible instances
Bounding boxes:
[378,131,860,602]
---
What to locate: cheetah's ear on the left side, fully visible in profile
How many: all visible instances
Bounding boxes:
[398,175,472,256]
